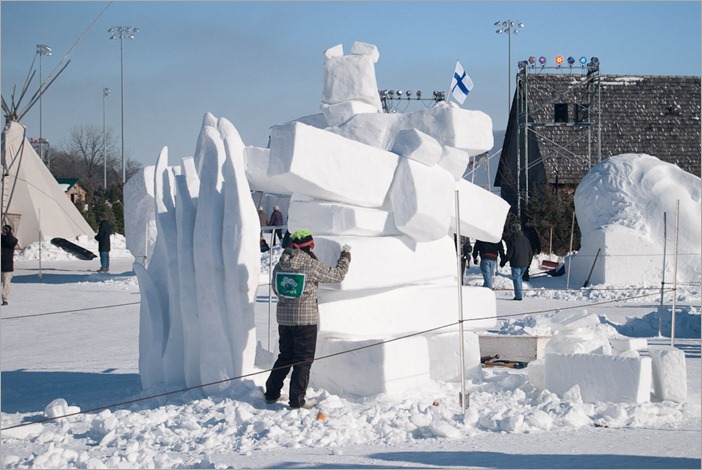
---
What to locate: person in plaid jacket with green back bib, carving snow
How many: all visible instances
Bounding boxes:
[265,230,351,408]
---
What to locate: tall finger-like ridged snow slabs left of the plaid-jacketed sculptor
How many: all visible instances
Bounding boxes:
[125,114,260,390]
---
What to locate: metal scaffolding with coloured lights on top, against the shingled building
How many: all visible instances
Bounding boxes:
[515,57,602,216]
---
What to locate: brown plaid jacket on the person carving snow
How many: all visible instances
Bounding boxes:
[273,248,349,326]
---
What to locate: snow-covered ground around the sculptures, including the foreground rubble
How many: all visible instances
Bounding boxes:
[1,239,702,468]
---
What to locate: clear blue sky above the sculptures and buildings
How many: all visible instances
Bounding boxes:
[0,0,701,164]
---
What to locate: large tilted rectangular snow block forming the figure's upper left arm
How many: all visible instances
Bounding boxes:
[268,122,399,207]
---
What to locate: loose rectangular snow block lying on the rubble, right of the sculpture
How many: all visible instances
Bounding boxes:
[544,352,652,403]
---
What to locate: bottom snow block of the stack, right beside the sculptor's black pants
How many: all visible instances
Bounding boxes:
[310,333,430,397]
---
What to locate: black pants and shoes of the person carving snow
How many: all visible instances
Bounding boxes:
[266,325,317,408]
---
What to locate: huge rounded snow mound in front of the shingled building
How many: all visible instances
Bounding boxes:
[571,154,702,285]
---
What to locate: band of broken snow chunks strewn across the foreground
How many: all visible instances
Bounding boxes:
[3,369,700,468]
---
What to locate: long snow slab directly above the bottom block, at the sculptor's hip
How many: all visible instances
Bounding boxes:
[319,282,496,338]
